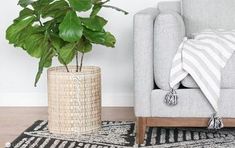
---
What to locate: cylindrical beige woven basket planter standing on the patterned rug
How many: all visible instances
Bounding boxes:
[47,66,101,134]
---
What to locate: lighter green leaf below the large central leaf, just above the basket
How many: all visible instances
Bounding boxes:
[59,43,76,64]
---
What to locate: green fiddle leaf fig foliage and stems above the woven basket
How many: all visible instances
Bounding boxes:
[6,0,128,86]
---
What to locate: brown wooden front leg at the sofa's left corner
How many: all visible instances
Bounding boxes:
[136,117,147,144]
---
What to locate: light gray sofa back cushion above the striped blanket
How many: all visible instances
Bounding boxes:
[182,0,235,36]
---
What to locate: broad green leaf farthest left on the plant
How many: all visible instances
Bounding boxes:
[6,17,35,44]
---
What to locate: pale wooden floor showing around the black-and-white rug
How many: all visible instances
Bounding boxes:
[0,107,135,147]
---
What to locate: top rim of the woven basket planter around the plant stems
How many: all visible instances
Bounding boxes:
[47,65,101,75]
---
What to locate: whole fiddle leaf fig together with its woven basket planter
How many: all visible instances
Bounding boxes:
[6,0,127,134]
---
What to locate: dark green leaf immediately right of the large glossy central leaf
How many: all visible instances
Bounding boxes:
[81,16,107,31]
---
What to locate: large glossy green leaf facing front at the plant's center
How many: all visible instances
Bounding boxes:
[59,11,83,42]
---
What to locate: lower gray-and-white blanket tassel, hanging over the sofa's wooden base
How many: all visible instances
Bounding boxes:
[208,113,224,130]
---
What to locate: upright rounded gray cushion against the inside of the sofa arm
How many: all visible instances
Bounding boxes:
[154,11,185,90]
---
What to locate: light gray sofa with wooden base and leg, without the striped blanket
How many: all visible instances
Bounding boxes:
[134,0,235,144]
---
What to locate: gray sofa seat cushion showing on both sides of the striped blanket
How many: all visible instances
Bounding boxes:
[182,53,235,89]
